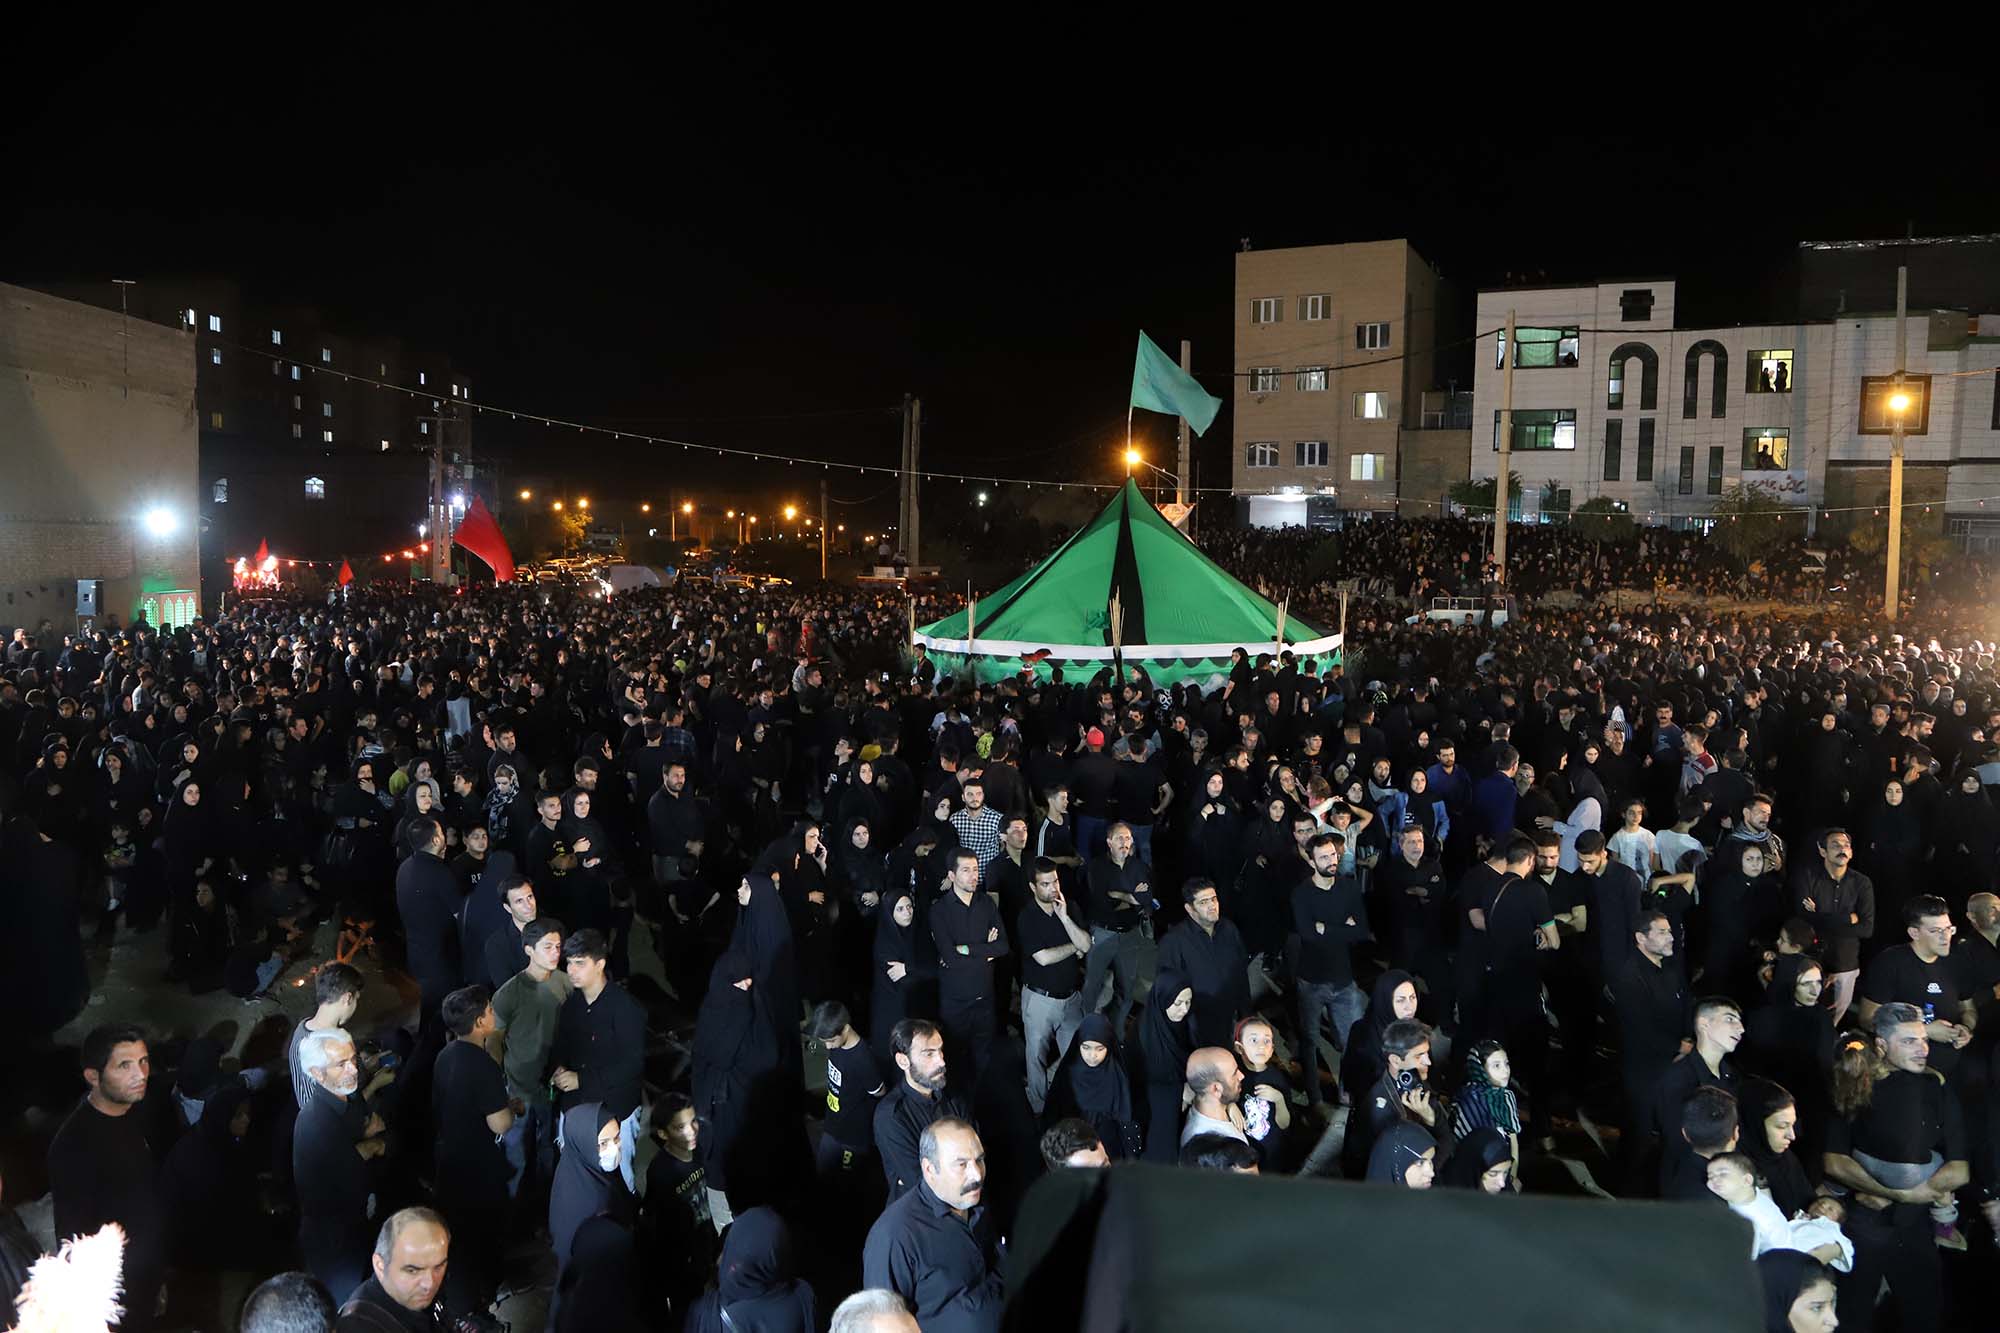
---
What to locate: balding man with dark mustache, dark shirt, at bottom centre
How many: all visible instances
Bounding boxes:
[862,1117,1006,1333]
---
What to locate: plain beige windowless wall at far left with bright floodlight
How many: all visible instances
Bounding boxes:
[0,284,198,632]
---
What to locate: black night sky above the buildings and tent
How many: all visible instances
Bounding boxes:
[0,4,2000,520]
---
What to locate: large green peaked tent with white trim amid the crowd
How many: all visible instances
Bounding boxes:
[914,480,1340,685]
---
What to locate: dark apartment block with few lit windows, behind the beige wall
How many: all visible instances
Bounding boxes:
[43,278,480,592]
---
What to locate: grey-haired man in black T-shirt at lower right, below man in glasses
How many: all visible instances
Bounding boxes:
[1826,1001,1972,1329]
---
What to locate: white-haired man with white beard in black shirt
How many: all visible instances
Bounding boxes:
[292,1027,388,1301]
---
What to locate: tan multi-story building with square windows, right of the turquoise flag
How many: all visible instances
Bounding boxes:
[1230,240,1452,526]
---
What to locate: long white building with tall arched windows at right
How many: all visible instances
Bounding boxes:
[1470,280,2000,538]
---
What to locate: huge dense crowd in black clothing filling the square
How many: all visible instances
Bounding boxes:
[0,522,2000,1333]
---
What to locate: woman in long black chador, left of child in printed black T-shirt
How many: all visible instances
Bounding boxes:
[692,951,780,1225]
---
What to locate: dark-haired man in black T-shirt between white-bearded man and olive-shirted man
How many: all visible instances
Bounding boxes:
[430,987,512,1307]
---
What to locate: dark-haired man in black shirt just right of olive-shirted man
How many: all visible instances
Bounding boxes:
[550,931,646,1189]
